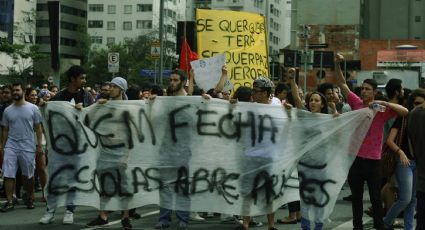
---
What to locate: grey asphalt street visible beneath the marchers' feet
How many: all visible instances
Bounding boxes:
[0,185,398,230]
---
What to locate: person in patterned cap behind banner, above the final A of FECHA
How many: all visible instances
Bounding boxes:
[235,76,277,230]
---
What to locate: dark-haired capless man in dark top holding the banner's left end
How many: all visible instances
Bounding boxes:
[39,65,94,224]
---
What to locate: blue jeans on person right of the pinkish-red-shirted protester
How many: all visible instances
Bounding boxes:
[384,160,416,230]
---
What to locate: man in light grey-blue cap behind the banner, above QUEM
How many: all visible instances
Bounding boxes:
[86,77,132,229]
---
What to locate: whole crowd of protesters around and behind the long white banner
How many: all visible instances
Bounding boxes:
[0,54,425,230]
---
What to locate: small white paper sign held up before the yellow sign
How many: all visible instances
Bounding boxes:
[190,54,227,92]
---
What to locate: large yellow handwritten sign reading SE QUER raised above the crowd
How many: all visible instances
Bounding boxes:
[196,9,269,90]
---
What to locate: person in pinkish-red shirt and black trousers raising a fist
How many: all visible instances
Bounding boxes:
[335,54,408,229]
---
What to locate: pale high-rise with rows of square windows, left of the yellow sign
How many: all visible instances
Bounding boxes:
[87,0,186,53]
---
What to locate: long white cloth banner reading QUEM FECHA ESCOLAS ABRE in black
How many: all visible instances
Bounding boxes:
[43,97,374,221]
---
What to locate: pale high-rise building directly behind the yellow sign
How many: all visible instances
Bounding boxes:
[186,0,291,57]
